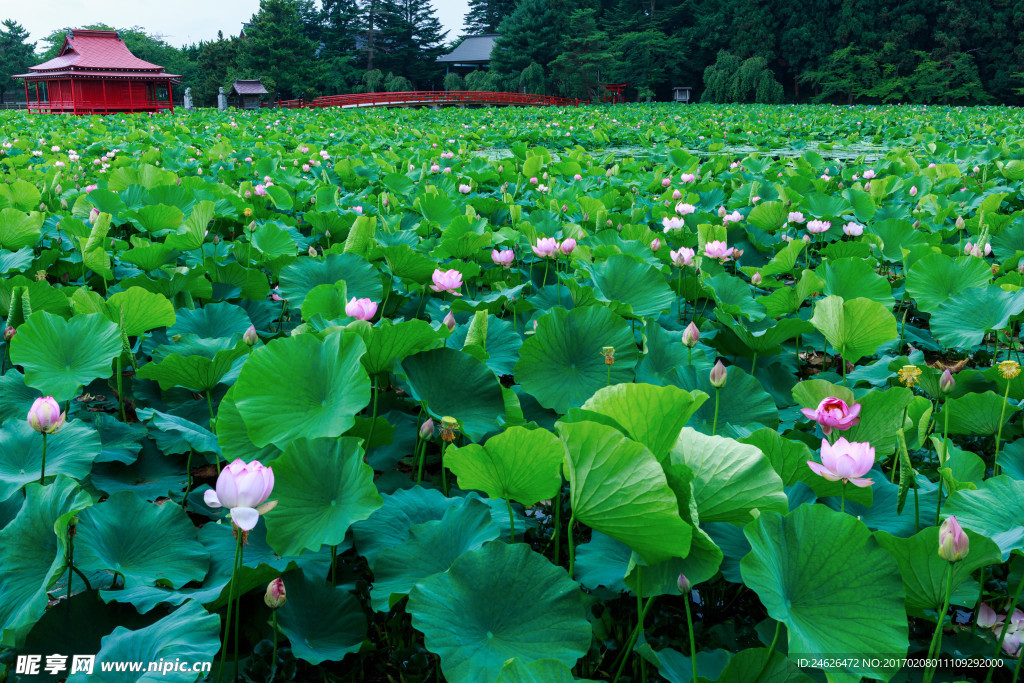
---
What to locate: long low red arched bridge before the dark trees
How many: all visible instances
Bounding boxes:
[278,90,580,109]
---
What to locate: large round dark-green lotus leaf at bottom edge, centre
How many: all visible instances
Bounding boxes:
[408,542,592,683]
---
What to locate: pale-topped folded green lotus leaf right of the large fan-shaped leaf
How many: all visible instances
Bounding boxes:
[669,427,788,525]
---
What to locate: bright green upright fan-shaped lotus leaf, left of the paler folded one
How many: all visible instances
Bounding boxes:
[557,422,692,564]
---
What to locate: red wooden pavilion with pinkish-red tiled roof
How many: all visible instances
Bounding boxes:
[13,30,180,114]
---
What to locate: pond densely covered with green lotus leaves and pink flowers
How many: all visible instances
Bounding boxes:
[0,105,1024,683]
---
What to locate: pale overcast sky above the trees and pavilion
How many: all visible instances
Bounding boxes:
[0,0,468,47]
